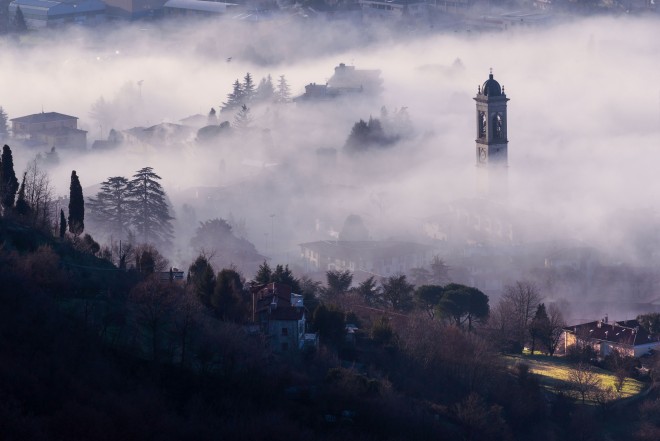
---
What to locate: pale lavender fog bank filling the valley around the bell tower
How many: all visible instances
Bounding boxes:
[0,13,660,268]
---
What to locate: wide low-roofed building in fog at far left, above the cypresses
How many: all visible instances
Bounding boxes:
[10,112,87,150]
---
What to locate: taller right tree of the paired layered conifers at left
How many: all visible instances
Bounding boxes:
[128,167,174,246]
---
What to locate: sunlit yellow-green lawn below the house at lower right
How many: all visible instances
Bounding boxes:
[504,355,646,398]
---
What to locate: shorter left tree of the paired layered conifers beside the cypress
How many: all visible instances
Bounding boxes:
[88,176,130,238]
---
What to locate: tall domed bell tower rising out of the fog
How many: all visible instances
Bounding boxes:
[474,69,509,197]
